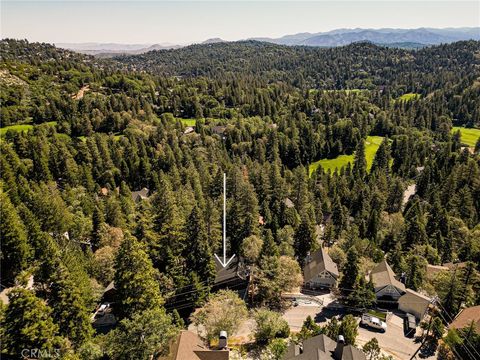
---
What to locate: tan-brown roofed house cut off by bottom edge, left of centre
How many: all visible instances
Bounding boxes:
[158,330,230,360]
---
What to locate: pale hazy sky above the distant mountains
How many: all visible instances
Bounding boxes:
[1,0,480,44]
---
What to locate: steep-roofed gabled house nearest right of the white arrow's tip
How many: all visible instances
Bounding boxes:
[303,248,339,289]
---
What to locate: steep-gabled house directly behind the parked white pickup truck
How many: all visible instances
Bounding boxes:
[370,259,406,304]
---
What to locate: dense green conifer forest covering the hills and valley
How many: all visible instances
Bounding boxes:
[0,40,480,359]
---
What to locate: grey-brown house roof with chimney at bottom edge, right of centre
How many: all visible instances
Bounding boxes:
[283,334,366,360]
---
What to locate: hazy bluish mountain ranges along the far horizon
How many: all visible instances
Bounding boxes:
[56,27,480,57]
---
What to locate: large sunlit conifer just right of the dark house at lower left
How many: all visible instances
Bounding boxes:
[114,235,163,317]
